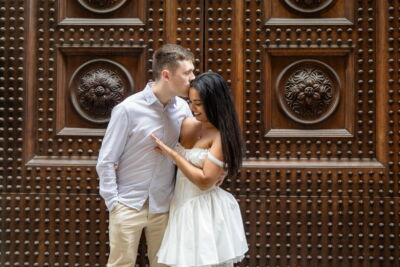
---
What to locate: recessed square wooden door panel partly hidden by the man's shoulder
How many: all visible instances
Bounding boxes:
[56,47,145,135]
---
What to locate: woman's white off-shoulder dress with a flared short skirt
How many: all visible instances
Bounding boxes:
[157,144,248,267]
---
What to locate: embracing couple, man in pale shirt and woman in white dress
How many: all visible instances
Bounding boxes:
[96,44,248,267]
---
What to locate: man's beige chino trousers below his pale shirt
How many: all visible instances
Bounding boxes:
[107,202,168,267]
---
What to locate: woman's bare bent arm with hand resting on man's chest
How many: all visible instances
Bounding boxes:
[152,135,225,190]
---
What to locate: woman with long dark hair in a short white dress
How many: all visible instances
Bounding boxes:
[153,72,248,267]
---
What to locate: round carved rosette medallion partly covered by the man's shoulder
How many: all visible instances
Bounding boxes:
[69,59,133,123]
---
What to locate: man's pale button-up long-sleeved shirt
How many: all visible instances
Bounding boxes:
[96,83,192,213]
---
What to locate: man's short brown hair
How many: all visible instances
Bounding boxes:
[152,44,194,81]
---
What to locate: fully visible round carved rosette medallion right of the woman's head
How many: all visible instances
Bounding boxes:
[275,59,340,124]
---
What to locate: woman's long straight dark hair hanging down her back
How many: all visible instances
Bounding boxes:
[190,72,243,177]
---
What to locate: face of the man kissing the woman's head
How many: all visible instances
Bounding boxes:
[170,60,195,98]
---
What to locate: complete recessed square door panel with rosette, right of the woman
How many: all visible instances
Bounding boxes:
[264,47,354,137]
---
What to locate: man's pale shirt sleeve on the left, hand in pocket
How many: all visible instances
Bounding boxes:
[96,105,129,211]
